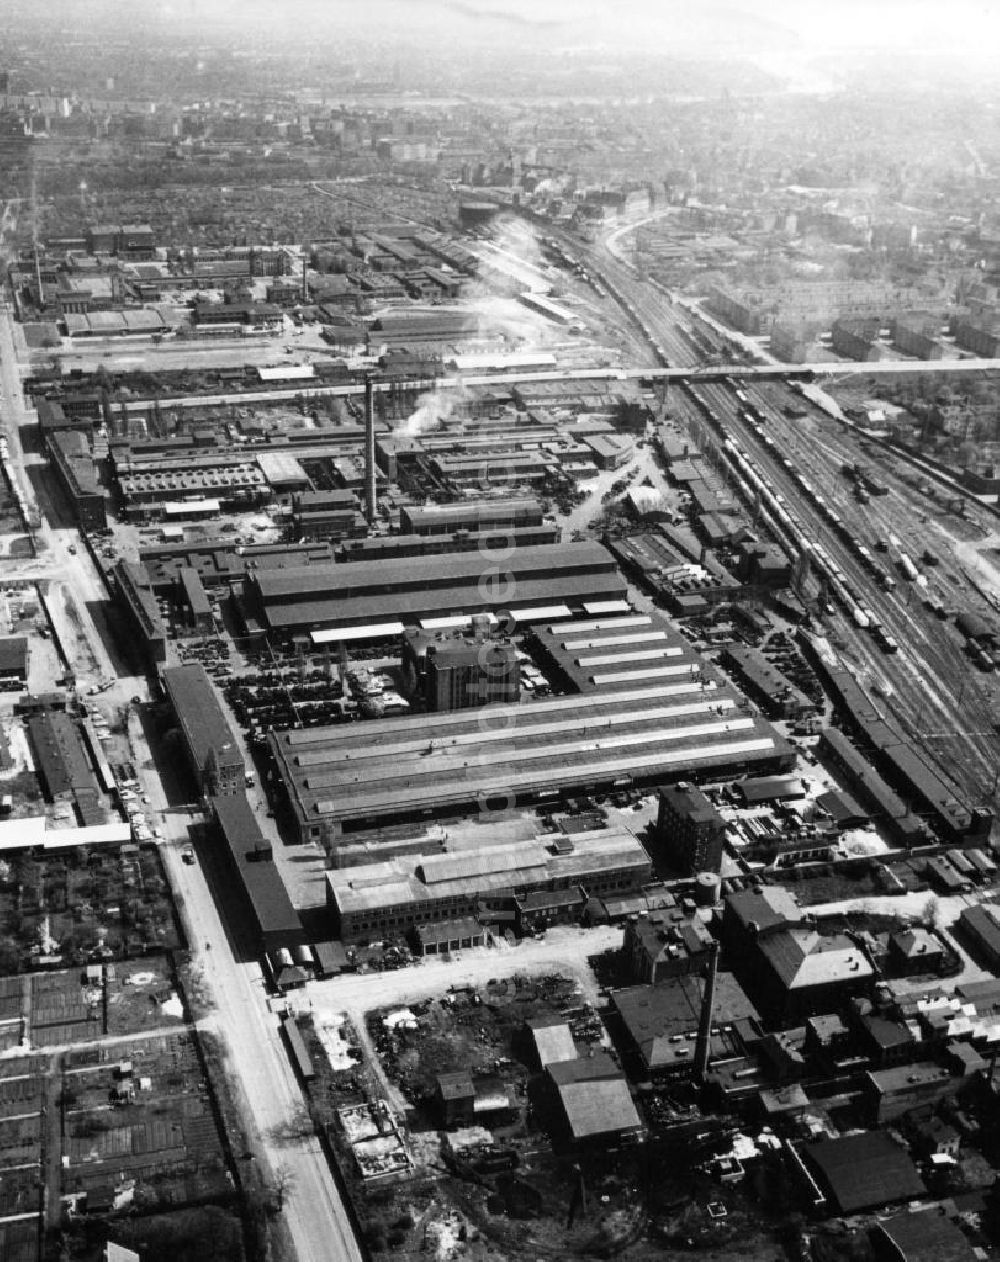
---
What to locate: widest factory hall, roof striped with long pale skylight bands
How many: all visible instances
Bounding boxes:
[269,678,792,843]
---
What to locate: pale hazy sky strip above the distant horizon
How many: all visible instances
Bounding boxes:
[0,0,1000,62]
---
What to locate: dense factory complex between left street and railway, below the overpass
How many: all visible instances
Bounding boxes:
[32,328,990,974]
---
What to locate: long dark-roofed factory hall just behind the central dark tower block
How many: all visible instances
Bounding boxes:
[244,543,626,639]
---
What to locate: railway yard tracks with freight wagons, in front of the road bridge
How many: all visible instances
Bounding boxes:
[691,385,1000,795]
